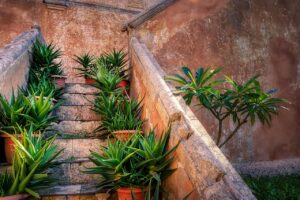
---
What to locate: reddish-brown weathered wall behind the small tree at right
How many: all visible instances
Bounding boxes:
[130,0,300,162]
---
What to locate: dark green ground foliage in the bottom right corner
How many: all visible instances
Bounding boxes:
[244,176,300,200]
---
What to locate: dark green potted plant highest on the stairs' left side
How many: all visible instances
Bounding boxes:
[29,40,66,88]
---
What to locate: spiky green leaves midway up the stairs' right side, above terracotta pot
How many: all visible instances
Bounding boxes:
[93,92,143,134]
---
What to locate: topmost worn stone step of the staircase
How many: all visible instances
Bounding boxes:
[64,83,99,95]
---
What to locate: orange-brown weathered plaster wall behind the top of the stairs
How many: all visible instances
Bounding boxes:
[0,0,133,82]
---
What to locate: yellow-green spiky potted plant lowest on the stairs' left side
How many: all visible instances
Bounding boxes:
[0,127,61,200]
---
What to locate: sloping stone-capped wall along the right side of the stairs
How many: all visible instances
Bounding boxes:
[130,38,255,199]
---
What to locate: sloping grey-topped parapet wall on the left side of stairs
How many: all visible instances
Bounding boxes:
[0,28,42,99]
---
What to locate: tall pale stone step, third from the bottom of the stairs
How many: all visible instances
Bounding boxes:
[54,138,106,160]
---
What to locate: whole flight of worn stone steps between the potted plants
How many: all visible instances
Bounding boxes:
[41,83,109,200]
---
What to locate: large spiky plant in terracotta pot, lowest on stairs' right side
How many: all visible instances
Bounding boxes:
[84,129,178,200]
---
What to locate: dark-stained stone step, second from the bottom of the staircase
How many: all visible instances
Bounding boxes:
[49,159,101,185]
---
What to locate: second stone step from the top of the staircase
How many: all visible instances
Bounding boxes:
[62,93,95,106]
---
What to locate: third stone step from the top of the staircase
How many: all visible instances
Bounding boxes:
[53,106,100,121]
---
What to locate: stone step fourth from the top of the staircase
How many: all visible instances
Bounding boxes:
[50,121,101,137]
